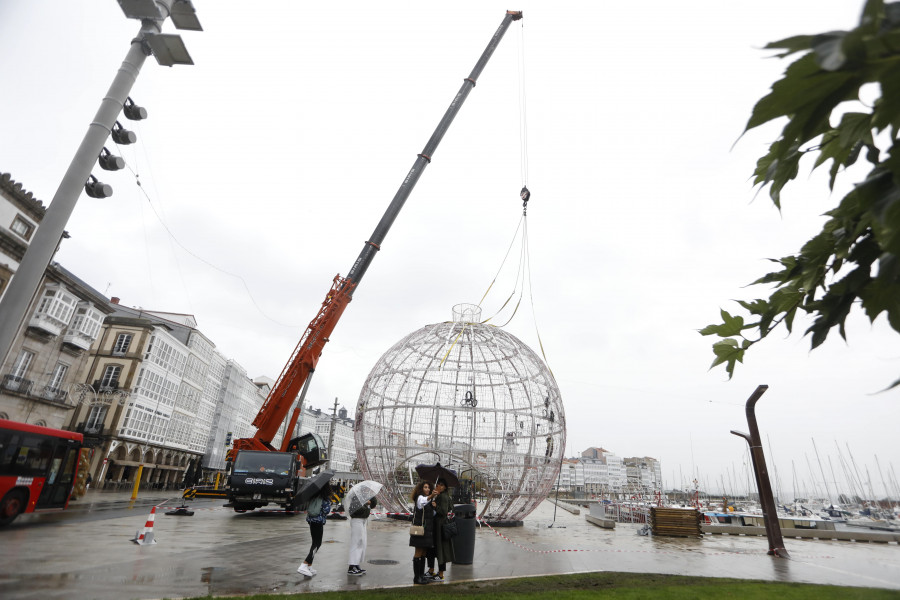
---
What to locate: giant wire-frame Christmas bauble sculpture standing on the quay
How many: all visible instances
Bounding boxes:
[355,304,566,522]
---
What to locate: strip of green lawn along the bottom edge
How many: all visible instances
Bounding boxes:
[179,573,900,600]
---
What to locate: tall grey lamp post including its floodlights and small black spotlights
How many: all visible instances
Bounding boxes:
[0,0,199,372]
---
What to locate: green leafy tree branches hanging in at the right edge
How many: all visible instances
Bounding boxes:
[700,0,900,388]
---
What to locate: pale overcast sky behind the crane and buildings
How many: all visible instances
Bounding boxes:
[0,0,900,495]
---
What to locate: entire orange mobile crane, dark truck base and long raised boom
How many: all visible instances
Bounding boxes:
[225,11,522,511]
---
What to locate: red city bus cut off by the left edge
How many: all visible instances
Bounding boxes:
[0,419,84,526]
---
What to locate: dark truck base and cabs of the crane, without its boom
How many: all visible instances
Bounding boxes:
[225,433,327,512]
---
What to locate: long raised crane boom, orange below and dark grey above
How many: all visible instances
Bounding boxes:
[234,11,522,452]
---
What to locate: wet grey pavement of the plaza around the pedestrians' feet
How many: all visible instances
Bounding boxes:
[0,491,900,600]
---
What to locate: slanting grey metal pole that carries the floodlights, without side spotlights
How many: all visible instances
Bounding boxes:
[0,0,192,365]
